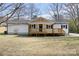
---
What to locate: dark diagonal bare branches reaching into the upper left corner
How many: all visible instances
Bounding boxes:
[0,3,22,24]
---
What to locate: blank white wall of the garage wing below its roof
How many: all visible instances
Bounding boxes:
[8,24,28,34]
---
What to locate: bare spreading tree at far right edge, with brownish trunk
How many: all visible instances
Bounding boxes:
[64,3,79,32]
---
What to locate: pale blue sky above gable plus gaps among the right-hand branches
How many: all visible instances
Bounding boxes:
[36,3,66,19]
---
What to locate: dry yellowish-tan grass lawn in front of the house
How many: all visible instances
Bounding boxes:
[0,35,79,56]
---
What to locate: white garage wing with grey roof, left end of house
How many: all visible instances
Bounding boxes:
[7,19,28,35]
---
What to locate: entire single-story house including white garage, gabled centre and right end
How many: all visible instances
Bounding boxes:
[7,17,69,35]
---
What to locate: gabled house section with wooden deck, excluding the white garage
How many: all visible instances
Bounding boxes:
[29,17,69,35]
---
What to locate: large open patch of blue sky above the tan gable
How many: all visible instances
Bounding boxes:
[35,3,50,19]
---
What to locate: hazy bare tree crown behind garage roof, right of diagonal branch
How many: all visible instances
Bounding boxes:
[13,3,40,19]
